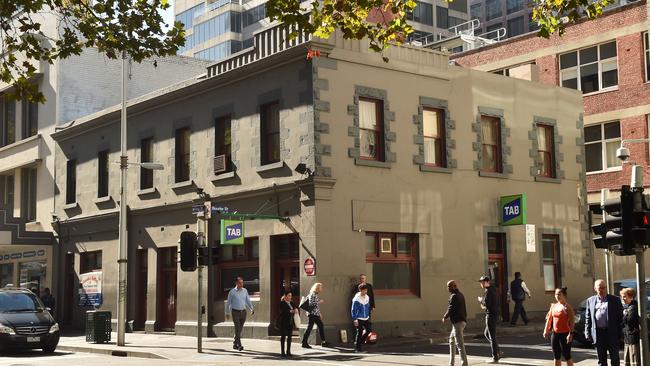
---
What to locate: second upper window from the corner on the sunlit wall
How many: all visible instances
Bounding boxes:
[422,108,446,167]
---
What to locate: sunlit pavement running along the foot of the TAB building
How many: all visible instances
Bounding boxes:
[57,323,543,360]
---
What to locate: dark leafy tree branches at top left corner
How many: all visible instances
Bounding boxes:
[0,0,185,102]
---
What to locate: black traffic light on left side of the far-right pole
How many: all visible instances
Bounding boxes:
[591,186,634,251]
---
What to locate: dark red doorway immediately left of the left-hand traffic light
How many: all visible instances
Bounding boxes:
[156,247,177,331]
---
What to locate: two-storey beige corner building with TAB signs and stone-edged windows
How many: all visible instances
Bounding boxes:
[53,27,593,341]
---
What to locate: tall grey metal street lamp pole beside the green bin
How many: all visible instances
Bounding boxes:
[117,52,129,346]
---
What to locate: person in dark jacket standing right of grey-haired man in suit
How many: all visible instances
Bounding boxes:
[621,287,641,366]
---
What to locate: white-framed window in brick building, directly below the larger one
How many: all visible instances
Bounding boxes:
[585,121,621,172]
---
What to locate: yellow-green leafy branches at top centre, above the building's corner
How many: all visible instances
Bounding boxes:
[266,0,416,60]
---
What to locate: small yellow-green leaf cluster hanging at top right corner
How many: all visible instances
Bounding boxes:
[533,0,614,38]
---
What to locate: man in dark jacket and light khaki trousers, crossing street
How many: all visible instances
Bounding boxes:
[442,281,468,366]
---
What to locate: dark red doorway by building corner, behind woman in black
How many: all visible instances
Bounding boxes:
[271,234,298,334]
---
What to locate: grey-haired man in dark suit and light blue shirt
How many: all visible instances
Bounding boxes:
[585,280,623,366]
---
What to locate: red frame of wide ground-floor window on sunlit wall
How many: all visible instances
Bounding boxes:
[364,231,420,297]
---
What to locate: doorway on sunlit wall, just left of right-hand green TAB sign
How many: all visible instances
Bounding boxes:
[488,233,510,322]
